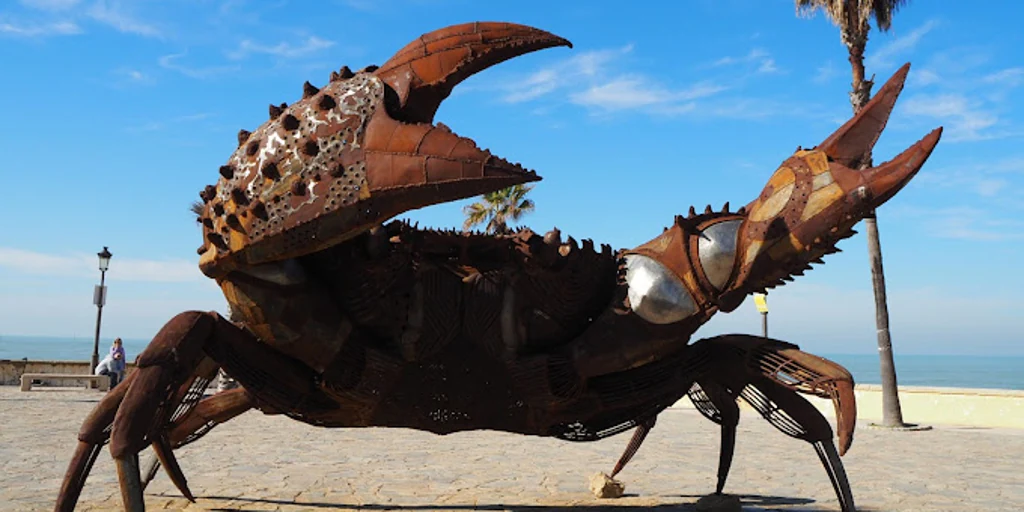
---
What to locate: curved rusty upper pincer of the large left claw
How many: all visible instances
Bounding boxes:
[376,22,572,123]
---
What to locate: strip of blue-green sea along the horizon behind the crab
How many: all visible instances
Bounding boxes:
[0,335,1024,390]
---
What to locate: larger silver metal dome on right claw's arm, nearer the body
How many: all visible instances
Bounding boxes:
[626,254,697,324]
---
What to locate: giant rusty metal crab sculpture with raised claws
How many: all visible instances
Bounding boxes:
[56,23,940,511]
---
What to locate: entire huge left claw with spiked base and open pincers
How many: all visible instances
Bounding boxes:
[199,23,571,279]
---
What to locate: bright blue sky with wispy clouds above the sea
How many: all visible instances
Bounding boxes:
[0,0,1024,354]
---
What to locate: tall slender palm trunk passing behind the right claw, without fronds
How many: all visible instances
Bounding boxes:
[843,30,904,427]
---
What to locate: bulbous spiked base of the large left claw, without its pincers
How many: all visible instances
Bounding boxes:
[200,74,384,271]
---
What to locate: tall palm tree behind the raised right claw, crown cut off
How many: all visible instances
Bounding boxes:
[796,0,907,427]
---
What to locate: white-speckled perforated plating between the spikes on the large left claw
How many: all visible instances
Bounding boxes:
[203,73,384,260]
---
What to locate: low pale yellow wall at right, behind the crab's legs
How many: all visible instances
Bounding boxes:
[674,384,1024,429]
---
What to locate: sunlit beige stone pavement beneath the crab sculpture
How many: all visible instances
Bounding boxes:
[0,387,1024,512]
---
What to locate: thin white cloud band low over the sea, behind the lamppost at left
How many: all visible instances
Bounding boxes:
[0,247,206,282]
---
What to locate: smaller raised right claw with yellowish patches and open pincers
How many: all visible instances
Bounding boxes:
[721,66,942,303]
